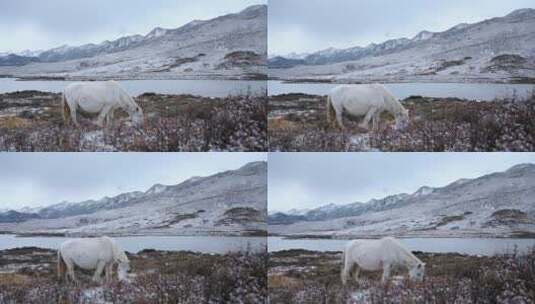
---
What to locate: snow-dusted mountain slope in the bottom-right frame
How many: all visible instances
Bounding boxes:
[268,164,535,237]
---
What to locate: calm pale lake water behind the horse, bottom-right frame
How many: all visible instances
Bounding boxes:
[268,237,535,255]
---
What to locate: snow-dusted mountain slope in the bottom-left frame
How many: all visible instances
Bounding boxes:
[0,162,267,235]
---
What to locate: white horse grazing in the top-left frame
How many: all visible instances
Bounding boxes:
[62,80,143,127]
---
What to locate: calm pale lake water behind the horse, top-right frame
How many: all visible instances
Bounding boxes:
[268,80,535,100]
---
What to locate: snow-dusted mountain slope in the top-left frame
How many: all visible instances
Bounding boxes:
[0,5,267,78]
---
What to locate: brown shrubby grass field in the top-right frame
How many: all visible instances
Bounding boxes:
[268,94,535,152]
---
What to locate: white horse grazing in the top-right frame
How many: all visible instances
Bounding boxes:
[326,84,409,130]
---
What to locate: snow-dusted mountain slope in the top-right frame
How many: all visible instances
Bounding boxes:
[269,9,535,82]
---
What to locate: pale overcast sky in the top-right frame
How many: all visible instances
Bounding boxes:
[268,0,535,55]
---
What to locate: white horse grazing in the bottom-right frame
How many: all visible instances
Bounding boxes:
[341,237,425,285]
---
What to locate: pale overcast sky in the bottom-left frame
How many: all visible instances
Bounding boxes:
[0,152,267,209]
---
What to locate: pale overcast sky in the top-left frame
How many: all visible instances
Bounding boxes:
[0,0,267,52]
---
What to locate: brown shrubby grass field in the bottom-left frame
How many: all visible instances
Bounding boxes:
[0,248,267,304]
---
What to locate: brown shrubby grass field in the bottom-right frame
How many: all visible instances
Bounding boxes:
[268,249,535,304]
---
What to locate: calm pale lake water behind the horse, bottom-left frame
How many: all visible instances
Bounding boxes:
[0,235,266,253]
